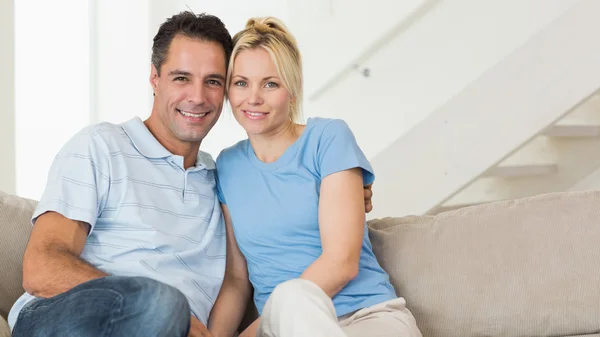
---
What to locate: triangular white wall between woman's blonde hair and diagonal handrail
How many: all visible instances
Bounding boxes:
[286,0,426,101]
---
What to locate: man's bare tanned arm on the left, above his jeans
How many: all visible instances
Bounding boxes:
[23,212,108,298]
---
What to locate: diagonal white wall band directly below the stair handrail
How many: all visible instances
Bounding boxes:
[306,0,578,158]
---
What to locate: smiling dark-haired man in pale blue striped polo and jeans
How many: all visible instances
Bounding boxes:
[9,12,371,337]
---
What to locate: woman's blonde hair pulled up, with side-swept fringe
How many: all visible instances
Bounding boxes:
[227,17,303,122]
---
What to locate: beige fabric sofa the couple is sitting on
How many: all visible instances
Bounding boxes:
[0,191,600,337]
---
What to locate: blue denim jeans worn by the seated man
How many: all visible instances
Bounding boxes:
[13,276,191,337]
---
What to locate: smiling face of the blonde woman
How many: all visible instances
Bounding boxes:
[228,48,292,136]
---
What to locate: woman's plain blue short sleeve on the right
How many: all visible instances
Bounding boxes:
[317,119,375,185]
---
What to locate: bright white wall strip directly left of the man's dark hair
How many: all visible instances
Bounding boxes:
[91,0,152,123]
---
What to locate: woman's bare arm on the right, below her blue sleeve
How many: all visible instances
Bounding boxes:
[300,168,365,297]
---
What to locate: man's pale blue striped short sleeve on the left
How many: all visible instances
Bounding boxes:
[32,129,110,233]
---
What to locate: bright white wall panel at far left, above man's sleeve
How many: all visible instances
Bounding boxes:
[15,0,91,199]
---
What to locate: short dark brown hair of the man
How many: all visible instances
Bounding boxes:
[152,11,233,76]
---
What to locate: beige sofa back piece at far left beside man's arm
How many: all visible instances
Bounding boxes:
[0,192,36,318]
